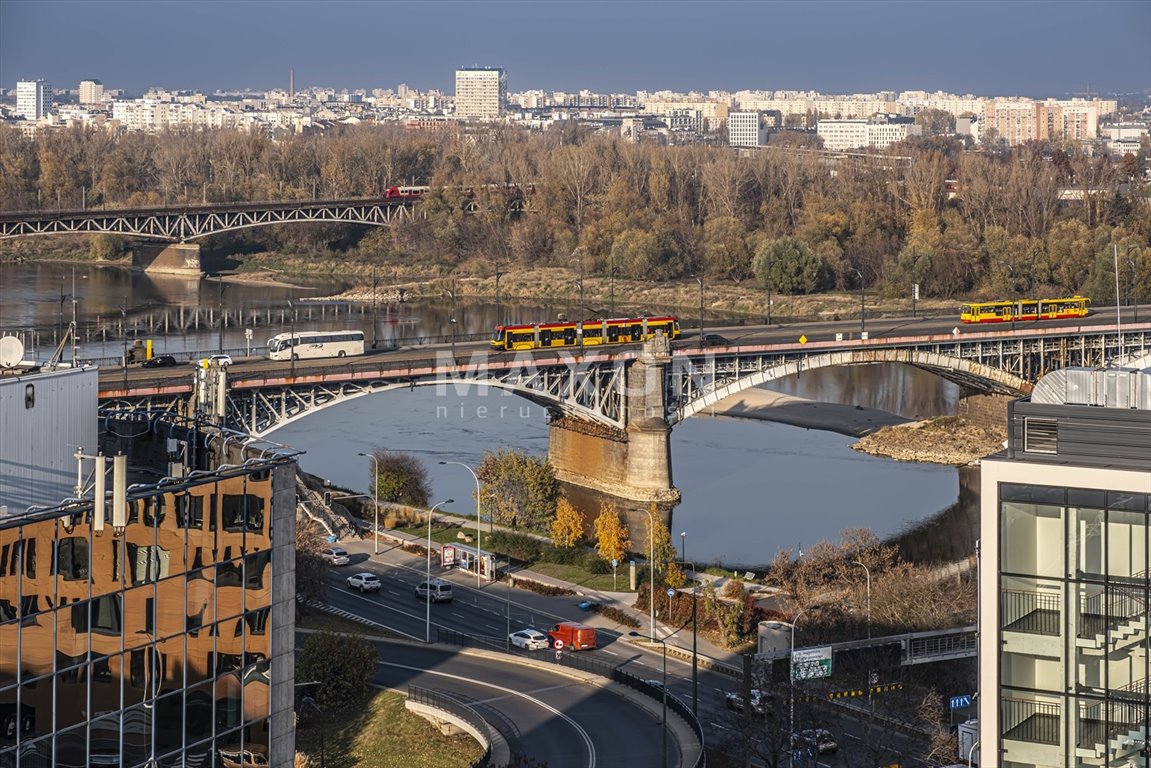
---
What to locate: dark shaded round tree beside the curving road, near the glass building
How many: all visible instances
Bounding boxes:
[296,632,380,712]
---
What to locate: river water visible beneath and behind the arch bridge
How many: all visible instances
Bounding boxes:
[0,264,974,567]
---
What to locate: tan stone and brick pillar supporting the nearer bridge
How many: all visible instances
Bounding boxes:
[548,336,679,507]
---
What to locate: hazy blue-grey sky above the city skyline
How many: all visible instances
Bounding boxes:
[0,0,1151,97]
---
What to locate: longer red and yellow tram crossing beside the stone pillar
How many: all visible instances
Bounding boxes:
[491,315,679,350]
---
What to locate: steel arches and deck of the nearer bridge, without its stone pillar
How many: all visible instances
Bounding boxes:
[102,325,1151,436]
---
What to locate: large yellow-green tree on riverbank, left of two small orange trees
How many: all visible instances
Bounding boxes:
[475,450,559,532]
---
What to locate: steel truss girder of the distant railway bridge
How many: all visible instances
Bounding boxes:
[0,200,411,242]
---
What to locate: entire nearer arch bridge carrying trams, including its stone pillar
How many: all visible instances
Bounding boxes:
[100,322,1151,511]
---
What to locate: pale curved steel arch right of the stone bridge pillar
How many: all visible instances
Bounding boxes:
[672,349,1032,423]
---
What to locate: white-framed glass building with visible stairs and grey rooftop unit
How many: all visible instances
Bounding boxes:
[976,368,1151,768]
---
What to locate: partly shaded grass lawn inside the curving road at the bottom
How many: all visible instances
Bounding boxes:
[296,691,482,768]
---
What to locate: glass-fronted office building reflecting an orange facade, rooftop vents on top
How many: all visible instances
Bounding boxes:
[0,368,296,768]
